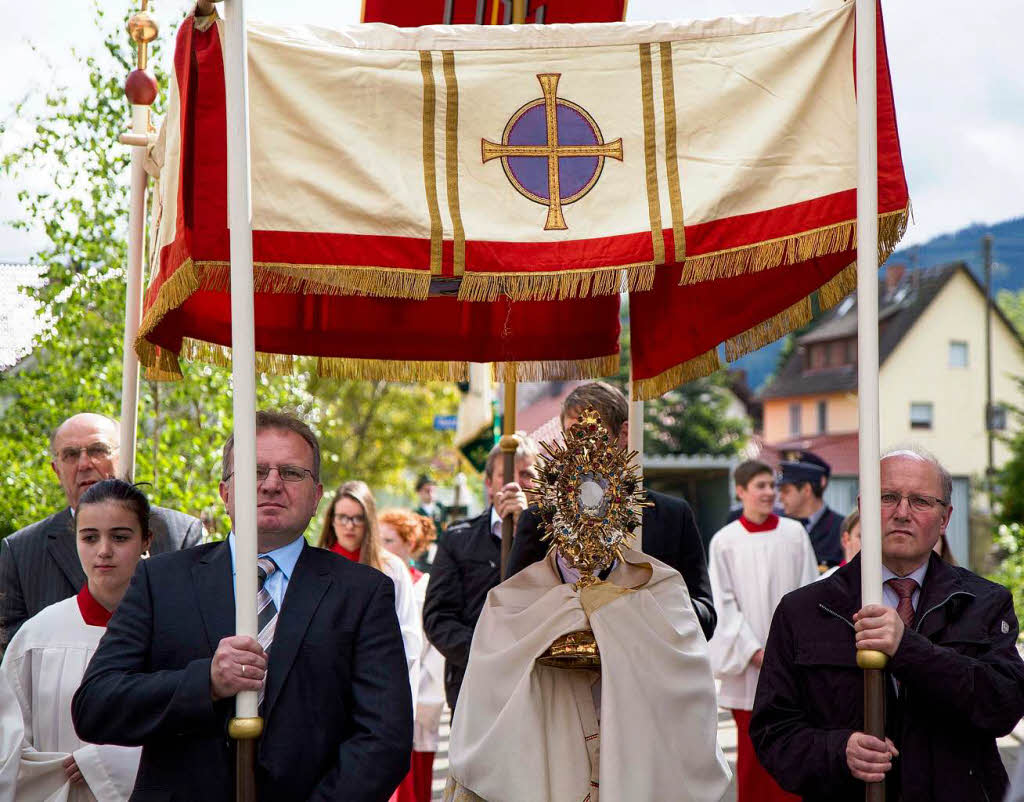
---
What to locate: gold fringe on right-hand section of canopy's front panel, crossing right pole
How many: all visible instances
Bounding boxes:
[679,204,910,285]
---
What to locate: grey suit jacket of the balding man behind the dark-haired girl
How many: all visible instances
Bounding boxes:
[0,507,203,643]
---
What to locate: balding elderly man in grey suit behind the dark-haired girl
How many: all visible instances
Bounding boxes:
[0,413,203,644]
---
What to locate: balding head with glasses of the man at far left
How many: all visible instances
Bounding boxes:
[50,412,121,509]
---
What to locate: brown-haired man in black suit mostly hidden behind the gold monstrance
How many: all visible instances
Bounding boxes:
[509,381,718,640]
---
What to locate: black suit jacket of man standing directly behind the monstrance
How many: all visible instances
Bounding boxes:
[505,491,718,640]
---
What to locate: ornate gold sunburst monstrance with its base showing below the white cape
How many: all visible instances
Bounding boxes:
[528,407,645,668]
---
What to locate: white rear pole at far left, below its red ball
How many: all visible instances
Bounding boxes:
[120,105,150,481]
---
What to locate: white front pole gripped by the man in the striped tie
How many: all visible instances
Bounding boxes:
[224,0,258,737]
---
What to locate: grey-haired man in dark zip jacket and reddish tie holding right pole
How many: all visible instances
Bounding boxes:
[751,448,1024,802]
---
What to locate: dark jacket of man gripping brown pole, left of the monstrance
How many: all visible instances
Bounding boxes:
[423,507,497,710]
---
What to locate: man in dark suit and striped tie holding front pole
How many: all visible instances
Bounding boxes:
[72,412,413,802]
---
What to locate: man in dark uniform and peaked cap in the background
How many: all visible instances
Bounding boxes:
[775,451,844,571]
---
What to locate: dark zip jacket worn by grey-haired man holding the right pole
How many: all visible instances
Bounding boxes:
[750,554,1024,802]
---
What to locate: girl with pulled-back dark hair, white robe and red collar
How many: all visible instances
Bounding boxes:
[0,479,152,802]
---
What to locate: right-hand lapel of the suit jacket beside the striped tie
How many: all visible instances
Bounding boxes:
[263,544,333,720]
